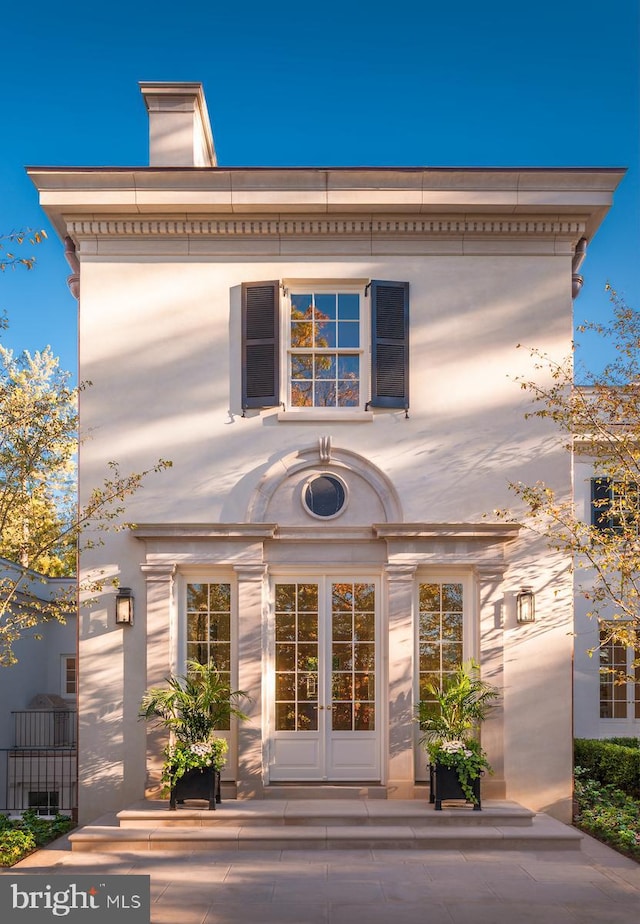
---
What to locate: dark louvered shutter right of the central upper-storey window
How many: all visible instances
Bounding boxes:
[369,279,409,408]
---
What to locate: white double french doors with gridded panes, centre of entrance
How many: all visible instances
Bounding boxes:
[269,577,381,782]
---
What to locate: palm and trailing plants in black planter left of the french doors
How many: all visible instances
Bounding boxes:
[139,661,248,809]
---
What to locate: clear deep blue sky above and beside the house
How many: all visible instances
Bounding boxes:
[0,0,640,370]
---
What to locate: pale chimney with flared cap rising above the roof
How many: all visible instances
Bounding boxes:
[140,81,217,167]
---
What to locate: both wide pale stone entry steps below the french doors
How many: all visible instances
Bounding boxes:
[69,798,581,852]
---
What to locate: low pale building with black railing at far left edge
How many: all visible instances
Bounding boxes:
[0,558,77,814]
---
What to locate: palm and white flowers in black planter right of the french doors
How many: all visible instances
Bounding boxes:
[416,661,499,811]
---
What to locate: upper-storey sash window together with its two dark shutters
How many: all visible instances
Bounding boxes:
[242,280,409,411]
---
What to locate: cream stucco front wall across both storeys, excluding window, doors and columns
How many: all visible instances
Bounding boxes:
[69,243,571,819]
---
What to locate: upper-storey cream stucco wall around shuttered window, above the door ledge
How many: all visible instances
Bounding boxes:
[80,256,571,522]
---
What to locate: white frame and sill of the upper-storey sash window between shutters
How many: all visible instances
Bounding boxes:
[277,279,373,423]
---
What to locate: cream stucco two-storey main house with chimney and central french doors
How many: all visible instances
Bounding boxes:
[29,83,623,821]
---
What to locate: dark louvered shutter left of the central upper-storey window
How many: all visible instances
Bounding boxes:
[242,281,280,408]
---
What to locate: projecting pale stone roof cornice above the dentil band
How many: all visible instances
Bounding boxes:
[28,167,624,238]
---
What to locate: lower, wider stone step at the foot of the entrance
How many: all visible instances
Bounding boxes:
[69,813,581,853]
